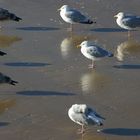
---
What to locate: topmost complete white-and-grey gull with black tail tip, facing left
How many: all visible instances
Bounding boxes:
[58,5,96,30]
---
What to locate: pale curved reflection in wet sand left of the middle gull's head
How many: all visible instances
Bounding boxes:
[60,34,92,58]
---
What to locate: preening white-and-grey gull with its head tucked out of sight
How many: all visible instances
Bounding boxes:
[68,104,105,134]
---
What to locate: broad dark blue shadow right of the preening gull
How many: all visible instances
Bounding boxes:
[102,128,140,136]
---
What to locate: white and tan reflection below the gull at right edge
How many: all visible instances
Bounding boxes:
[116,39,140,61]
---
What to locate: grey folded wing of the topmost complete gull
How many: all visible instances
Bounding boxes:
[65,10,87,23]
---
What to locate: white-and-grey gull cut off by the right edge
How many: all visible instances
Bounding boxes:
[114,12,140,36]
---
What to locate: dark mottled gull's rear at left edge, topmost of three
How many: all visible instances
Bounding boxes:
[0,8,22,27]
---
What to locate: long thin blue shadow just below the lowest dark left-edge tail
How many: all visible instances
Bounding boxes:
[16,91,75,96]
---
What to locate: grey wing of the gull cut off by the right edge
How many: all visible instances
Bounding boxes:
[122,16,140,28]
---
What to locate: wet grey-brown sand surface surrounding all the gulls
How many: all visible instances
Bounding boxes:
[0,0,140,140]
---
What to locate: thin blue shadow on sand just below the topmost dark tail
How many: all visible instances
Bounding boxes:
[16,26,59,31]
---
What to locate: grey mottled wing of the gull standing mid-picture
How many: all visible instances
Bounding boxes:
[87,46,108,57]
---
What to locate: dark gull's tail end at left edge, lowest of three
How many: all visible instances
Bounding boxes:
[0,72,18,85]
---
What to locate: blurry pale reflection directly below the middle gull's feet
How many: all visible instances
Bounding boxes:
[80,71,110,94]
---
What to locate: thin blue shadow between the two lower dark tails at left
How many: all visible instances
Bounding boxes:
[4,62,51,67]
